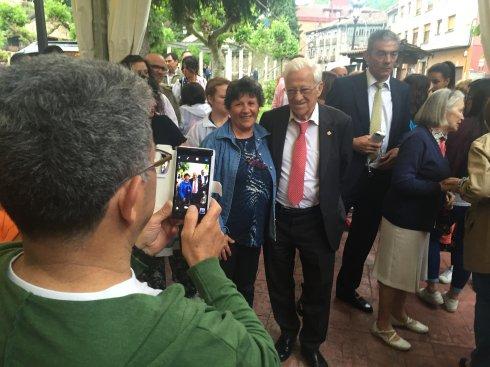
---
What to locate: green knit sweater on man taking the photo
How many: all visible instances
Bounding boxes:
[0,244,279,367]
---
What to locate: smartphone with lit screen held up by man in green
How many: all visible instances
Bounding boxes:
[172,147,215,219]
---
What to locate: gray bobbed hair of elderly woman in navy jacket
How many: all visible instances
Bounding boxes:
[415,88,464,128]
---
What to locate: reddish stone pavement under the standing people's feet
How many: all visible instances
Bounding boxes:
[254,234,475,367]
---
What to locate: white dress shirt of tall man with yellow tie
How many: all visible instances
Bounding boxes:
[366,69,393,154]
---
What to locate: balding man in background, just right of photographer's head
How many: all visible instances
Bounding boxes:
[145,53,180,126]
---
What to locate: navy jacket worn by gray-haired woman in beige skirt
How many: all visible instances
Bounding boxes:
[383,126,451,232]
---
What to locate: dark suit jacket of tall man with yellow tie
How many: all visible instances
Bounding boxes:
[325,72,410,202]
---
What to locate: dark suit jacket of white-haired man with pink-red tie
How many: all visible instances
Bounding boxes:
[260,105,352,250]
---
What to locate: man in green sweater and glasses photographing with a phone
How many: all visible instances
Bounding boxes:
[0,56,279,367]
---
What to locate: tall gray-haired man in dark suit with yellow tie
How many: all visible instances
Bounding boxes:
[326,30,410,312]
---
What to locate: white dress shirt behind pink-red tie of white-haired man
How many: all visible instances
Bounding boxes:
[276,103,320,209]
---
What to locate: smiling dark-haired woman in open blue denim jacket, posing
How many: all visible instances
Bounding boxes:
[201,77,276,306]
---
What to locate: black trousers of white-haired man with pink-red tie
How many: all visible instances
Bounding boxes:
[264,205,335,350]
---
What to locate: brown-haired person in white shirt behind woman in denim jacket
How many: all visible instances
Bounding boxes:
[185,77,230,147]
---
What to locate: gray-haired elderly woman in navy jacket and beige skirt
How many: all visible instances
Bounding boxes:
[371,88,464,350]
